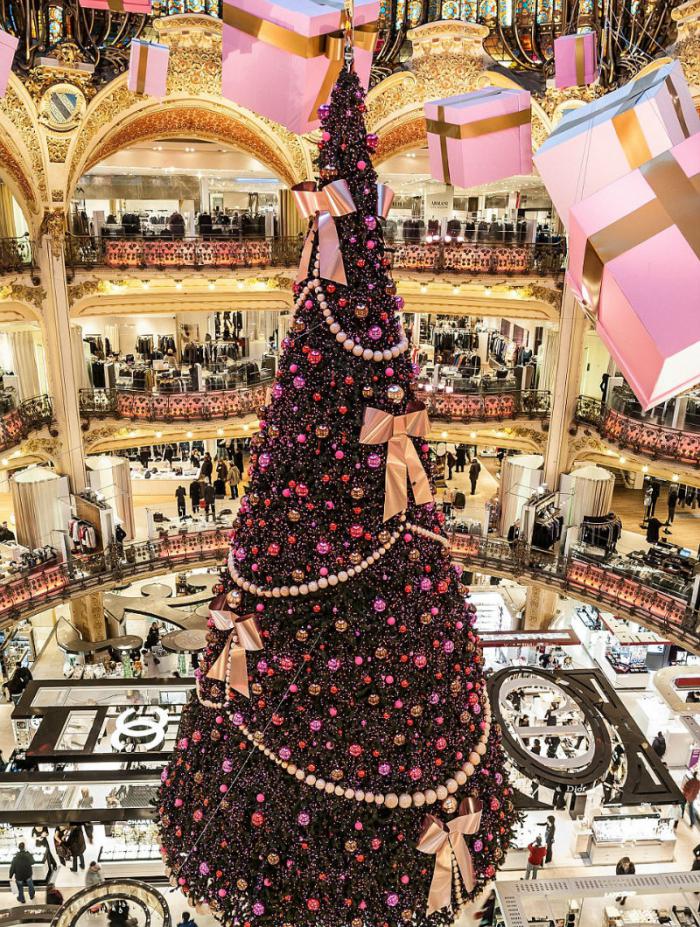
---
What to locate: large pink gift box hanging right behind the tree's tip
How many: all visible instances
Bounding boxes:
[222,0,379,134]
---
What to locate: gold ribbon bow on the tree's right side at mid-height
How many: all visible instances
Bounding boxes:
[360,406,433,521]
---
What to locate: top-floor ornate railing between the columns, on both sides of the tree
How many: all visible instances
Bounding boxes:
[66,232,564,277]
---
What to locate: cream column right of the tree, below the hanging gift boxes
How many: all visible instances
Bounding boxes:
[544,286,588,489]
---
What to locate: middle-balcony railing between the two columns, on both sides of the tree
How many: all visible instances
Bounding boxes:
[80,379,551,422]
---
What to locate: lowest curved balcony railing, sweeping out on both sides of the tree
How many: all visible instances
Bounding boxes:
[0,526,700,652]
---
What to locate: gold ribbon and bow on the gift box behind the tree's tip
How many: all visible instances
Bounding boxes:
[223,0,379,119]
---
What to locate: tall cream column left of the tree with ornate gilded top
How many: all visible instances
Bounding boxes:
[37,209,85,492]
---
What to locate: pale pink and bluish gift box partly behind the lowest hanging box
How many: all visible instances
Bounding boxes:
[534,61,700,229]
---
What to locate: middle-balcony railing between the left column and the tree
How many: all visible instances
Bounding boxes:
[80,378,272,422]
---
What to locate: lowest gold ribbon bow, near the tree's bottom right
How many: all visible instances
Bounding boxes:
[416,798,483,917]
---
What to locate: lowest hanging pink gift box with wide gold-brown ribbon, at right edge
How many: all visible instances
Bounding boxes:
[568,134,700,409]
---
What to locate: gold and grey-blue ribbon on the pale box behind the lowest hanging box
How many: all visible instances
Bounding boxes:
[549,64,690,170]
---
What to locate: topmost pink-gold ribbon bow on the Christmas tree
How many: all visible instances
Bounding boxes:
[292,180,356,286]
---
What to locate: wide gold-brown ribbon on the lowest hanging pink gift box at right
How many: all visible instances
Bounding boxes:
[581,151,700,314]
